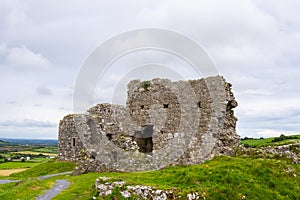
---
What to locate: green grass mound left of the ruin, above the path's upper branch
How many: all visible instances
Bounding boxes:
[10,160,75,178]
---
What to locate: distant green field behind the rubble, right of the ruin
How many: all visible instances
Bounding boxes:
[241,135,300,147]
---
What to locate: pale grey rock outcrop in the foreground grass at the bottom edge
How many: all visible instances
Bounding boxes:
[95,177,200,200]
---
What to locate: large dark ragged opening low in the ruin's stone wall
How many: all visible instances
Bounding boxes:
[134,125,153,153]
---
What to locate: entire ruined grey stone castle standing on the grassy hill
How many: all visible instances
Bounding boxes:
[58,76,240,173]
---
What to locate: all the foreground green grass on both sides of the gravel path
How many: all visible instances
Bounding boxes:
[0,157,300,200]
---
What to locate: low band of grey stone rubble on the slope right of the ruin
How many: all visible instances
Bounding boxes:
[237,143,300,164]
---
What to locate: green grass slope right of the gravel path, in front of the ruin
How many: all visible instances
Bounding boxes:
[55,157,300,199]
